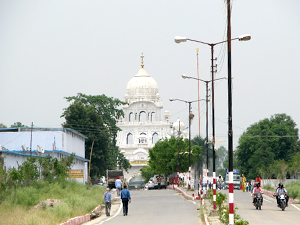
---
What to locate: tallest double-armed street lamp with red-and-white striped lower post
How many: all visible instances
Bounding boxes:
[175,34,251,210]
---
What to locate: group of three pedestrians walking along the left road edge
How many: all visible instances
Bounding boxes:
[104,177,131,216]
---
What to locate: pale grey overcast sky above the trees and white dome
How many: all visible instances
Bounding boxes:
[0,0,300,148]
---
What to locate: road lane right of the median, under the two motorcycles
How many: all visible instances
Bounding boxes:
[222,190,300,225]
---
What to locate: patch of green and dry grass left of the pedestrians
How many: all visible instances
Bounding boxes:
[0,180,105,225]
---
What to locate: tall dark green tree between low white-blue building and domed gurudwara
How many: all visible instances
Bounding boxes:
[62,93,130,177]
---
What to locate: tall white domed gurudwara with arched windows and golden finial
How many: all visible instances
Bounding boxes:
[117,54,173,185]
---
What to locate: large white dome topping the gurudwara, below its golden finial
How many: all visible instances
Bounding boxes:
[125,68,159,103]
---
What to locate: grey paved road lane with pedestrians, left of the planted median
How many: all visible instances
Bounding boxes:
[85,189,201,225]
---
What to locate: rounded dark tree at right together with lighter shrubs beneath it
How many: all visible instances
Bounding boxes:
[235,114,300,179]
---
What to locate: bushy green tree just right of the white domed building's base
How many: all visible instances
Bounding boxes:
[149,137,202,174]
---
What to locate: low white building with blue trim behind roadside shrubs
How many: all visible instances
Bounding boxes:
[0,127,89,182]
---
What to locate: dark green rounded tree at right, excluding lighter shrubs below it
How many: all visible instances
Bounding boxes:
[236,114,299,178]
